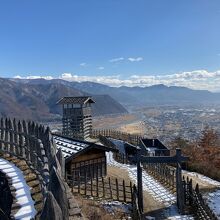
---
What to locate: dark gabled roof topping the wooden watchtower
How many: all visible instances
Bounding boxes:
[57,96,95,105]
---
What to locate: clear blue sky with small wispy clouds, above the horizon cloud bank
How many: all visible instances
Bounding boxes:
[0,0,220,90]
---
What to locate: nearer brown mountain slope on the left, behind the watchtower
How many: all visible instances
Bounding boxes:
[0,78,127,121]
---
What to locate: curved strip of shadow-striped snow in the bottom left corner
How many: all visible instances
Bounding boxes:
[0,158,37,220]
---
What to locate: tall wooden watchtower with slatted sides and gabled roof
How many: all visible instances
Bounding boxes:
[57,96,95,140]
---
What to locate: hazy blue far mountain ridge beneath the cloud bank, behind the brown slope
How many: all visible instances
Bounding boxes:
[12,79,220,107]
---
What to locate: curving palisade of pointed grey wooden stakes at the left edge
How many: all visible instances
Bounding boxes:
[0,118,50,195]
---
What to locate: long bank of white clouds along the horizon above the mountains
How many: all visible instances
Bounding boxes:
[12,70,220,91]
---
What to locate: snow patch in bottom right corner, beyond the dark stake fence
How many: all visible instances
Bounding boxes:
[204,189,220,219]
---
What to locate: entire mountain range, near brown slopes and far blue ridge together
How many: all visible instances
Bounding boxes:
[0,78,220,120]
